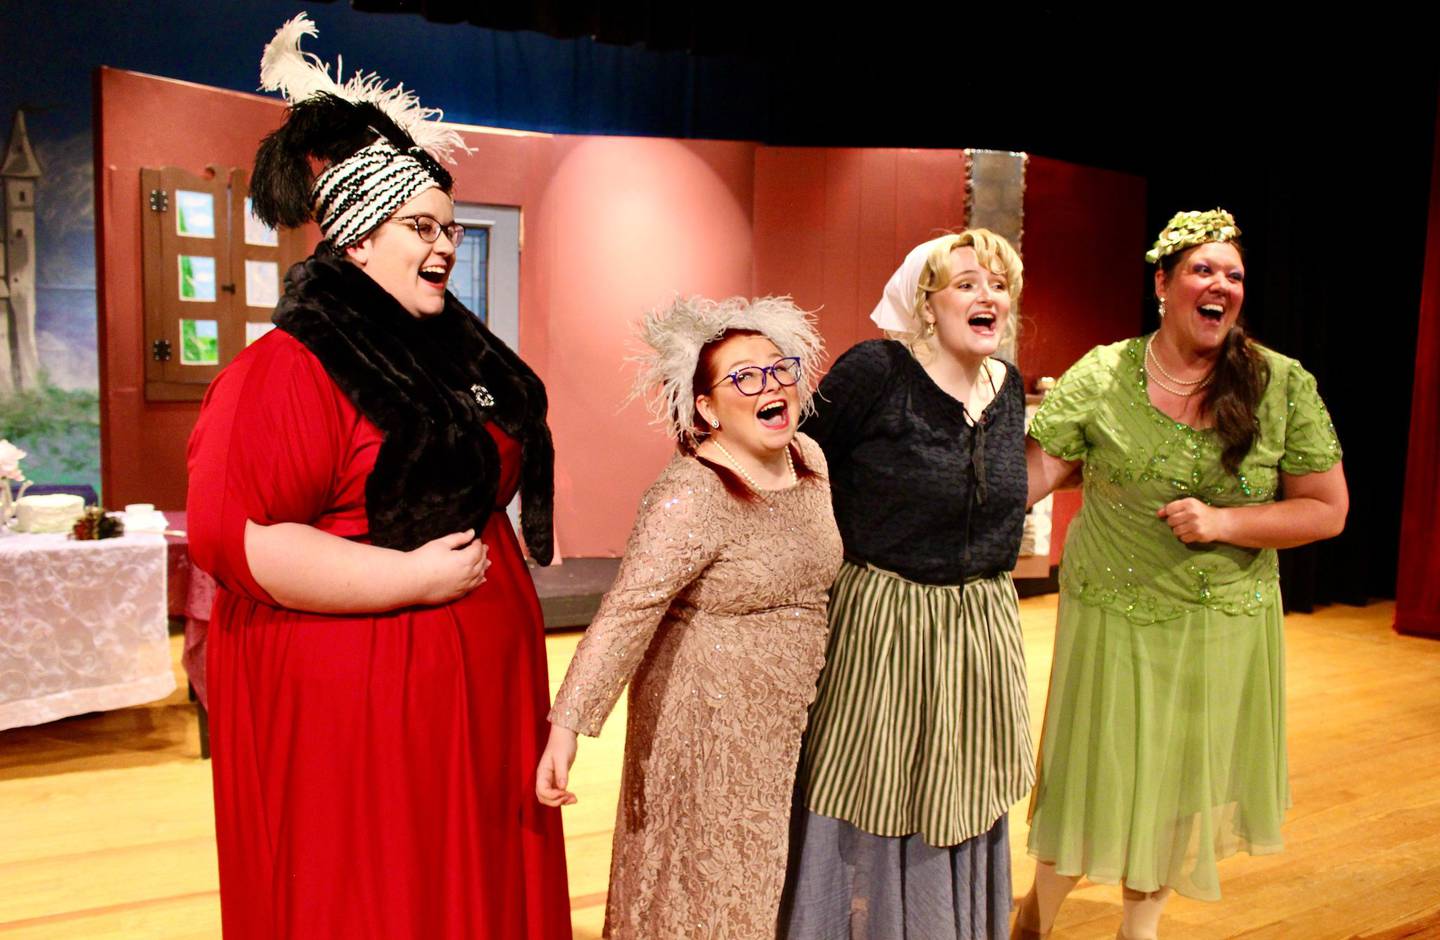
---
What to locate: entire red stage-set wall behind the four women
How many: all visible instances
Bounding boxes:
[95,69,1145,556]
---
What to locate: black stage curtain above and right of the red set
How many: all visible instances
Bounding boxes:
[331,0,1440,601]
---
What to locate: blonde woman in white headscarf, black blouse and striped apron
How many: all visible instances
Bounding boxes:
[780,229,1034,940]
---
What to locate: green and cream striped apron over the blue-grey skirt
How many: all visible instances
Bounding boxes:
[799,561,1035,846]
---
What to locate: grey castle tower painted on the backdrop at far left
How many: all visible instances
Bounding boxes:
[0,111,40,396]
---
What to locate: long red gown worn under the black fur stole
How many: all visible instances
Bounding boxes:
[189,330,570,940]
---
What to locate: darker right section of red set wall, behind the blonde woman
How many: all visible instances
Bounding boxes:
[755,147,1145,381]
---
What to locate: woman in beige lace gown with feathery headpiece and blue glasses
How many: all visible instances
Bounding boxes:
[536,299,841,940]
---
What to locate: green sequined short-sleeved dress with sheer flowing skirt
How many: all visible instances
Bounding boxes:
[1030,337,1341,900]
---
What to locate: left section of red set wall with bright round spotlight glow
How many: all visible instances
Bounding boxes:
[95,69,755,556]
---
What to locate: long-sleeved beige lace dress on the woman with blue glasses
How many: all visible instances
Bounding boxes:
[550,435,841,940]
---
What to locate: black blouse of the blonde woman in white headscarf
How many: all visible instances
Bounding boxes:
[802,340,1025,584]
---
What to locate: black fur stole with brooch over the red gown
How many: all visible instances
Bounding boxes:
[274,242,554,564]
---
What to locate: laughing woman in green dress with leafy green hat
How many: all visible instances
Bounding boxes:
[1014,209,1348,940]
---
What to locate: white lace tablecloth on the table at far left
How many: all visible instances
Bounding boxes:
[0,534,176,730]
